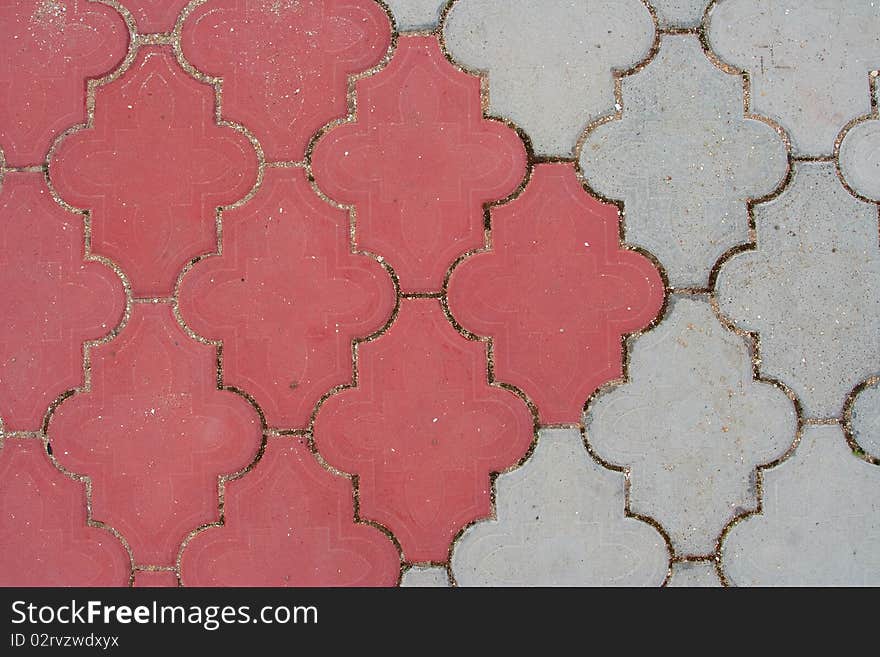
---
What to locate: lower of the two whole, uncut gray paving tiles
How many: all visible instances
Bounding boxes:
[585,297,797,555]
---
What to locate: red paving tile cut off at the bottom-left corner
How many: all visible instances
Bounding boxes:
[0,440,131,586]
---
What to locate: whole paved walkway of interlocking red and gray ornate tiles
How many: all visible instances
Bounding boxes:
[0,0,880,586]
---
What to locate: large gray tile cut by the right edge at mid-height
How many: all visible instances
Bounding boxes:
[716,162,880,417]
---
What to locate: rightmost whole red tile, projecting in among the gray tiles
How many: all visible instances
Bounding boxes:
[448,163,665,424]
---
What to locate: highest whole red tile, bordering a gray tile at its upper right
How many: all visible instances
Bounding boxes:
[312,37,526,292]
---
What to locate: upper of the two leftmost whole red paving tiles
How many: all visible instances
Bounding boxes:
[49,47,258,296]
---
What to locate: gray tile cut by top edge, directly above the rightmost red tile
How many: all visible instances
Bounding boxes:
[444,0,654,156]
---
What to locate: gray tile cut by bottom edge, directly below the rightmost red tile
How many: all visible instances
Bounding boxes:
[452,429,668,586]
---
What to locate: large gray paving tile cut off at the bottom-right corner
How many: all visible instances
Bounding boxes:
[722,426,880,586]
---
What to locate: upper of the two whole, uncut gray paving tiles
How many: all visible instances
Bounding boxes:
[581,35,788,287]
